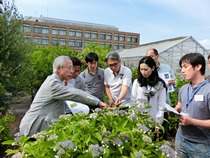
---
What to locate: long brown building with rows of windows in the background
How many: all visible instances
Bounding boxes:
[23,17,140,52]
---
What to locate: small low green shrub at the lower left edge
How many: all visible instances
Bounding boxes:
[0,114,15,142]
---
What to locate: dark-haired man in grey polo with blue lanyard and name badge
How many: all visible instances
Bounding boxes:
[175,53,210,158]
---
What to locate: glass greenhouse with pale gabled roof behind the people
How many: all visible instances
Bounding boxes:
[117,36,209,73]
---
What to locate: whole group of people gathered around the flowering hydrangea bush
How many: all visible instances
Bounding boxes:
[20,49,210,158]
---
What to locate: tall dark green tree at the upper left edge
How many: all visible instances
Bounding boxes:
[0,1,28,113]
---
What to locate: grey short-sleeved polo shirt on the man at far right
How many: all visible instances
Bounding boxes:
[179,81,210,144]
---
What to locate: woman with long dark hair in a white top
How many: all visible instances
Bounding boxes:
[131,56,167,125]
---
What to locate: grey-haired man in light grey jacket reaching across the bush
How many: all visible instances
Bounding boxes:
[20,56,107,136]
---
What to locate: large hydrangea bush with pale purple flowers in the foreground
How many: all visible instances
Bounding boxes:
[4,103,174,158]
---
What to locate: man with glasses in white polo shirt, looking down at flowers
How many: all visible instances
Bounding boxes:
[104,52,132,107]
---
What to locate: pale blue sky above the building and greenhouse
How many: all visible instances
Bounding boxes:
[11,0,210,49]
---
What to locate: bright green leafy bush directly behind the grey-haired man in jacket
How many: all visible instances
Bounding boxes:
[21,46,77,98]
